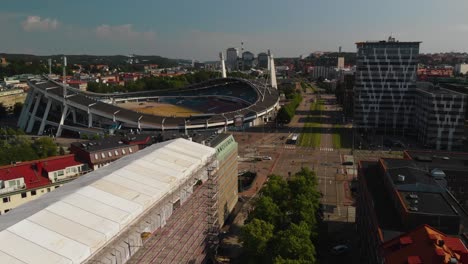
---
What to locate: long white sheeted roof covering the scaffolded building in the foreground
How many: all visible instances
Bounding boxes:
[0,139,215,264]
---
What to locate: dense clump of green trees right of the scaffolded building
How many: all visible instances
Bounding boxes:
[241,168,320,264]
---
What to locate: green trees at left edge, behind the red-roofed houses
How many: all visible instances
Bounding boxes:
[0,128,59,166]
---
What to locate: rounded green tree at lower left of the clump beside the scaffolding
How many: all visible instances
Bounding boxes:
[241,219,274,259]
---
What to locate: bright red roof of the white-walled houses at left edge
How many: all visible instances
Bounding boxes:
[0,154,81,189]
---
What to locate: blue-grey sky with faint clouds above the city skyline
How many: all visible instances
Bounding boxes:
[0,0,468,61]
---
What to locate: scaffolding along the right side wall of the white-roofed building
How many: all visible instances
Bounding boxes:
[123,157,219,264]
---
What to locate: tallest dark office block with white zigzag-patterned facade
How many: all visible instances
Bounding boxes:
[354,37,421,131]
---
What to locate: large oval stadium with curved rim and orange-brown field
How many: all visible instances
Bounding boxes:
[18,76,279,136]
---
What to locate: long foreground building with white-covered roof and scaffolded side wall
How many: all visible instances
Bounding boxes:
[0,135,237,264]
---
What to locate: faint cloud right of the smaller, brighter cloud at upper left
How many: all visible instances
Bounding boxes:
[95,24,156,41]
